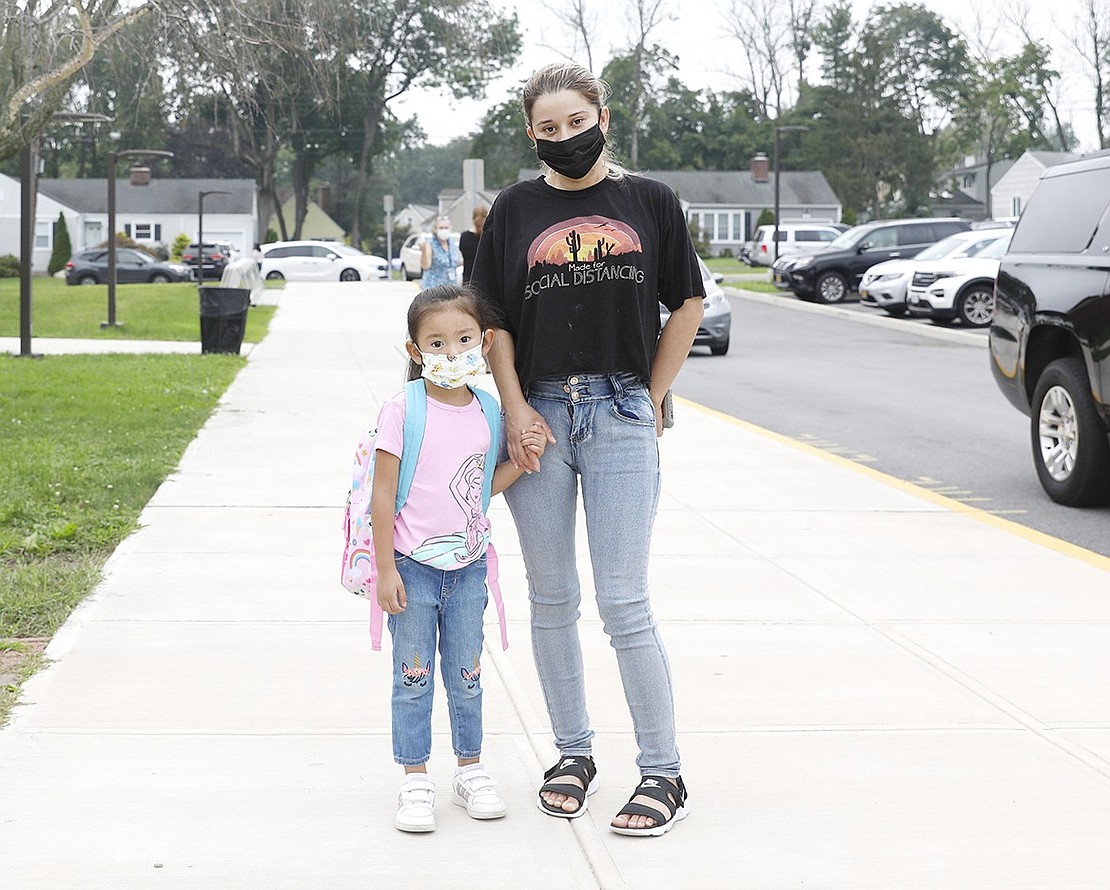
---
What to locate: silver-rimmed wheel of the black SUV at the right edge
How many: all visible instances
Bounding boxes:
[1029,357,1110,507]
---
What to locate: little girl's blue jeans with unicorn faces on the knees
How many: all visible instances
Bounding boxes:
[389,554,486,766]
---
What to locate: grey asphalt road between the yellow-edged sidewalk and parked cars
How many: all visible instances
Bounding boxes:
[675,291,1110,556]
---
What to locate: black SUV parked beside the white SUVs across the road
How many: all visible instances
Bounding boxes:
[774,219,971,303]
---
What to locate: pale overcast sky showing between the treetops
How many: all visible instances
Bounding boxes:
[394,0,1098,151]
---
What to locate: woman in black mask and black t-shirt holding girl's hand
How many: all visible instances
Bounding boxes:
[472,64,703,836]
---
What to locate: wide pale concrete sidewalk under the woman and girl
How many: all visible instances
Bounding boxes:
[0,283,1110,890]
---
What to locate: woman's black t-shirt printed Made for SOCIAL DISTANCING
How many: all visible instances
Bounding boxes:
[471,175,705,385]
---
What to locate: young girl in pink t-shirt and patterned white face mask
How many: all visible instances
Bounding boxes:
[371,284,545,831]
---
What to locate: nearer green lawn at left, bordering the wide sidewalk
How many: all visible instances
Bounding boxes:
[0,350,245,721]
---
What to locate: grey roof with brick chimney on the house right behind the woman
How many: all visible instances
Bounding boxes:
[519,169,840,208]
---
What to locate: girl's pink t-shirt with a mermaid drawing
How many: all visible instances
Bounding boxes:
[376,392,493,569]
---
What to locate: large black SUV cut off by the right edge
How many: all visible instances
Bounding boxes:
[990,153,1110,507]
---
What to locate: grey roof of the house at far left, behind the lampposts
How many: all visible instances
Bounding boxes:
[39,176,255,214]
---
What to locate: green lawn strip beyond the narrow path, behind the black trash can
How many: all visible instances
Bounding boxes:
[0,276,275,343]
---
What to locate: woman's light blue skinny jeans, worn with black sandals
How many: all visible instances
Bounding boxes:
[505,374,680,777]
